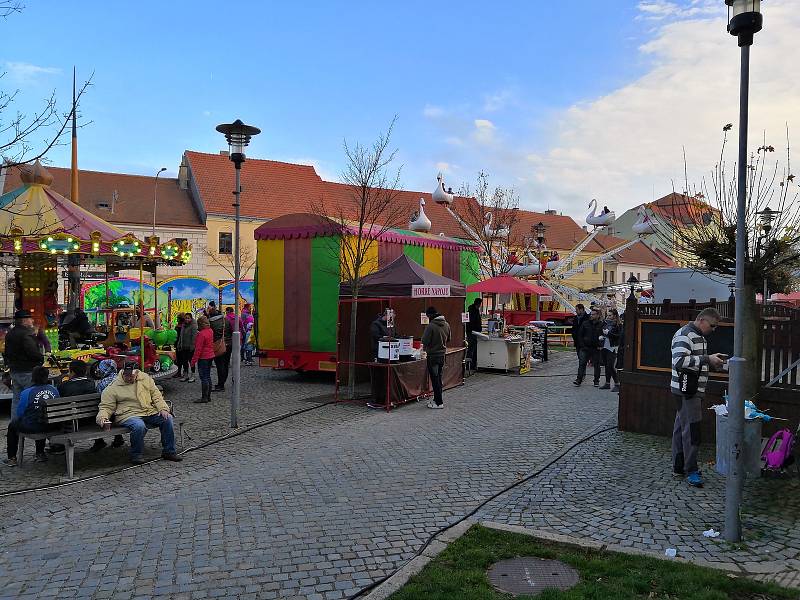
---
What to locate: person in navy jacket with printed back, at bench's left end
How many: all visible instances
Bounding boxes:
[4,367,58,467]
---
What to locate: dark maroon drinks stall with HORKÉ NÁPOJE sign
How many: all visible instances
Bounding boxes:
[336,255,466,410]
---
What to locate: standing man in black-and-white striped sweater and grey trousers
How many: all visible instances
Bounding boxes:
[670,308,727,487]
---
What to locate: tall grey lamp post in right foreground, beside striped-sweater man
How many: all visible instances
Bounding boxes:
[725,0,763,542]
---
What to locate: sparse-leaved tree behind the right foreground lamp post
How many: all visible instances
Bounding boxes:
[656,124,800,397]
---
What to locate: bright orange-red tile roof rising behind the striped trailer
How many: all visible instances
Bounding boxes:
[185,151,466,238]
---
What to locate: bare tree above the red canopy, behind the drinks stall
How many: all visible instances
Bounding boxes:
[456,171,532,279]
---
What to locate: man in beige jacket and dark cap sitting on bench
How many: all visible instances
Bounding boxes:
[96,362,183,465]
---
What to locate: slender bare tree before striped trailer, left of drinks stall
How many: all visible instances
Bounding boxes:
[312,117,408,398]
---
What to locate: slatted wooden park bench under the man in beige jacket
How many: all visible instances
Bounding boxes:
[17,393,183,479]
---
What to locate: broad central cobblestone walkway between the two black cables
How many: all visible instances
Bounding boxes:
[0,354,617,600]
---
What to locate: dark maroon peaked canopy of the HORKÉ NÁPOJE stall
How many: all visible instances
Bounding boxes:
[340,254,466,298]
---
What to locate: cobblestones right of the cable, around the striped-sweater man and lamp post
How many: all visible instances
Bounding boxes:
[478,431,800,587]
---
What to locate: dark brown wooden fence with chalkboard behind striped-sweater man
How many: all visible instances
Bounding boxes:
[619,298,800,441]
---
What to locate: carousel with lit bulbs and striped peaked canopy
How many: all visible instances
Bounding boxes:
[0,162,191,378]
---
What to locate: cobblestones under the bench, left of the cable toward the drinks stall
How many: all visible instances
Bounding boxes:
[0,367,334,493]
